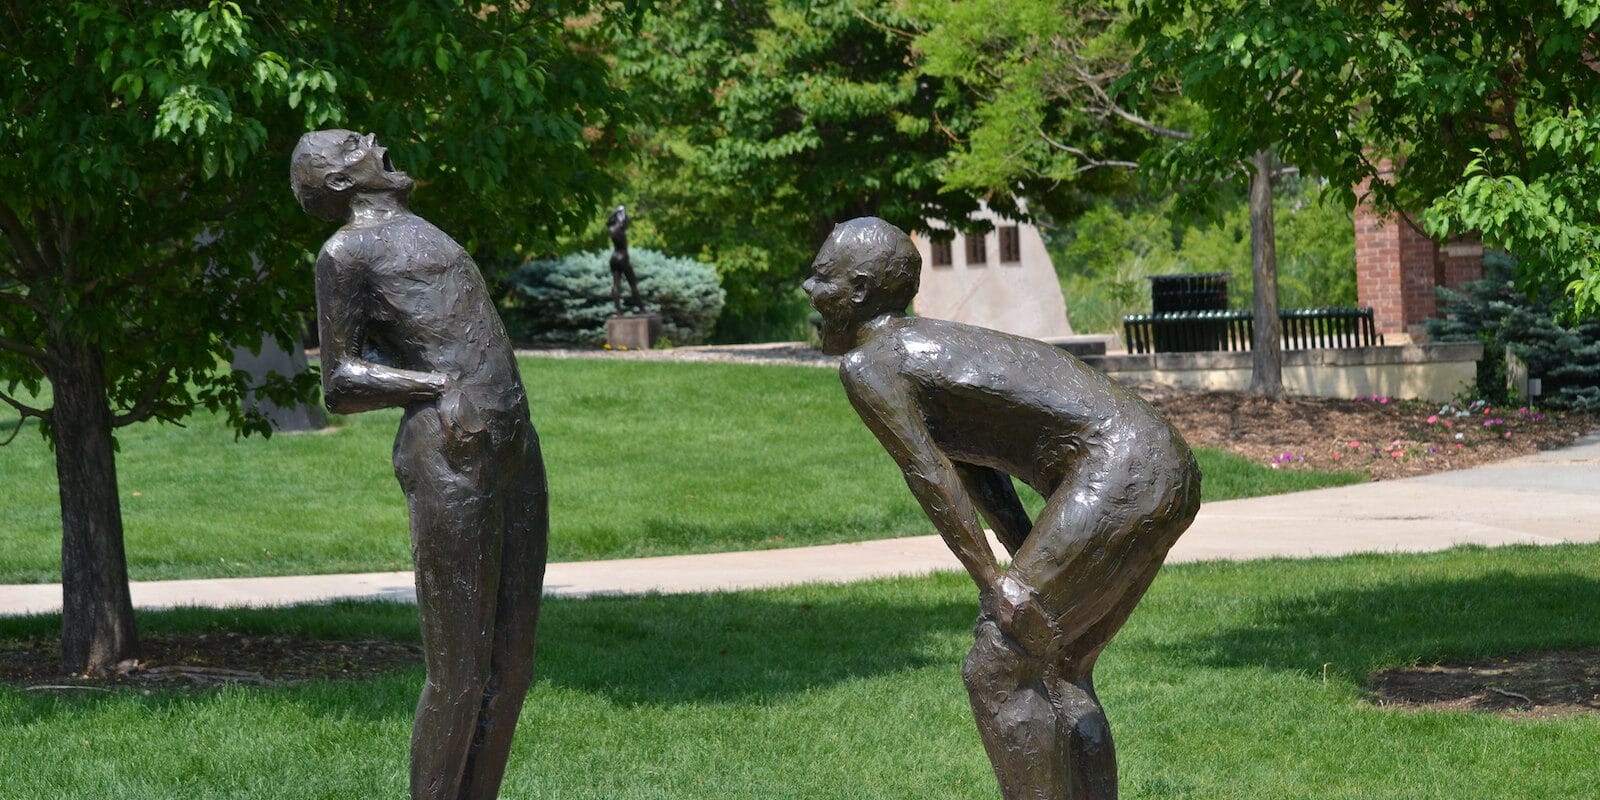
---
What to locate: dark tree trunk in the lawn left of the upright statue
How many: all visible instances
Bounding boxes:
[50,331,139,675]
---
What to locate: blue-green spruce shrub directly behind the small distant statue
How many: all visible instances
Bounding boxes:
[501,248,725,346]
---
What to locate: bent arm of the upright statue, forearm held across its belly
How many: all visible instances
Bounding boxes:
[317,248,446,414]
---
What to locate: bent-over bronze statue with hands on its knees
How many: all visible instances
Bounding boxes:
[805,218,1200,800]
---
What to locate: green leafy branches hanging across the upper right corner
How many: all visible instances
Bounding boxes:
[1134,0,1600,312]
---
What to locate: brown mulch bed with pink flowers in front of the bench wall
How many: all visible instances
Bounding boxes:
[1138,387,1600,480]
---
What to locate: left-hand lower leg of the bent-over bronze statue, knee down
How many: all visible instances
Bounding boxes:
[962,619,1074,800]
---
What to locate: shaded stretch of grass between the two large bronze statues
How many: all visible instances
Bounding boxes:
[539,584,978,704]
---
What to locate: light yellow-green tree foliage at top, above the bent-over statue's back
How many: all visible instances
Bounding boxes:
[909,0,1174,216]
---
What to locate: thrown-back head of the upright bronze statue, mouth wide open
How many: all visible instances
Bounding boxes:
[290,130,416,221]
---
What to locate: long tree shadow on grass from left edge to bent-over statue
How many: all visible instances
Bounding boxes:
[0,582,978,722]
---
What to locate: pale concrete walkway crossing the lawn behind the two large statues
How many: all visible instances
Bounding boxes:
[0,432,1600,614]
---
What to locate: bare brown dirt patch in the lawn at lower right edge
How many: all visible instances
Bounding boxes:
[1366,648,1600,718]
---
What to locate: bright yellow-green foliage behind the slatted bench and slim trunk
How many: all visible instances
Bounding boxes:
[1051,181,1355,333]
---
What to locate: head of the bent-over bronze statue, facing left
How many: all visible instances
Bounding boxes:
[805,216,922,355]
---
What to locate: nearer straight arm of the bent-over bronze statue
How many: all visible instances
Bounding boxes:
[840,363,1000,600]
